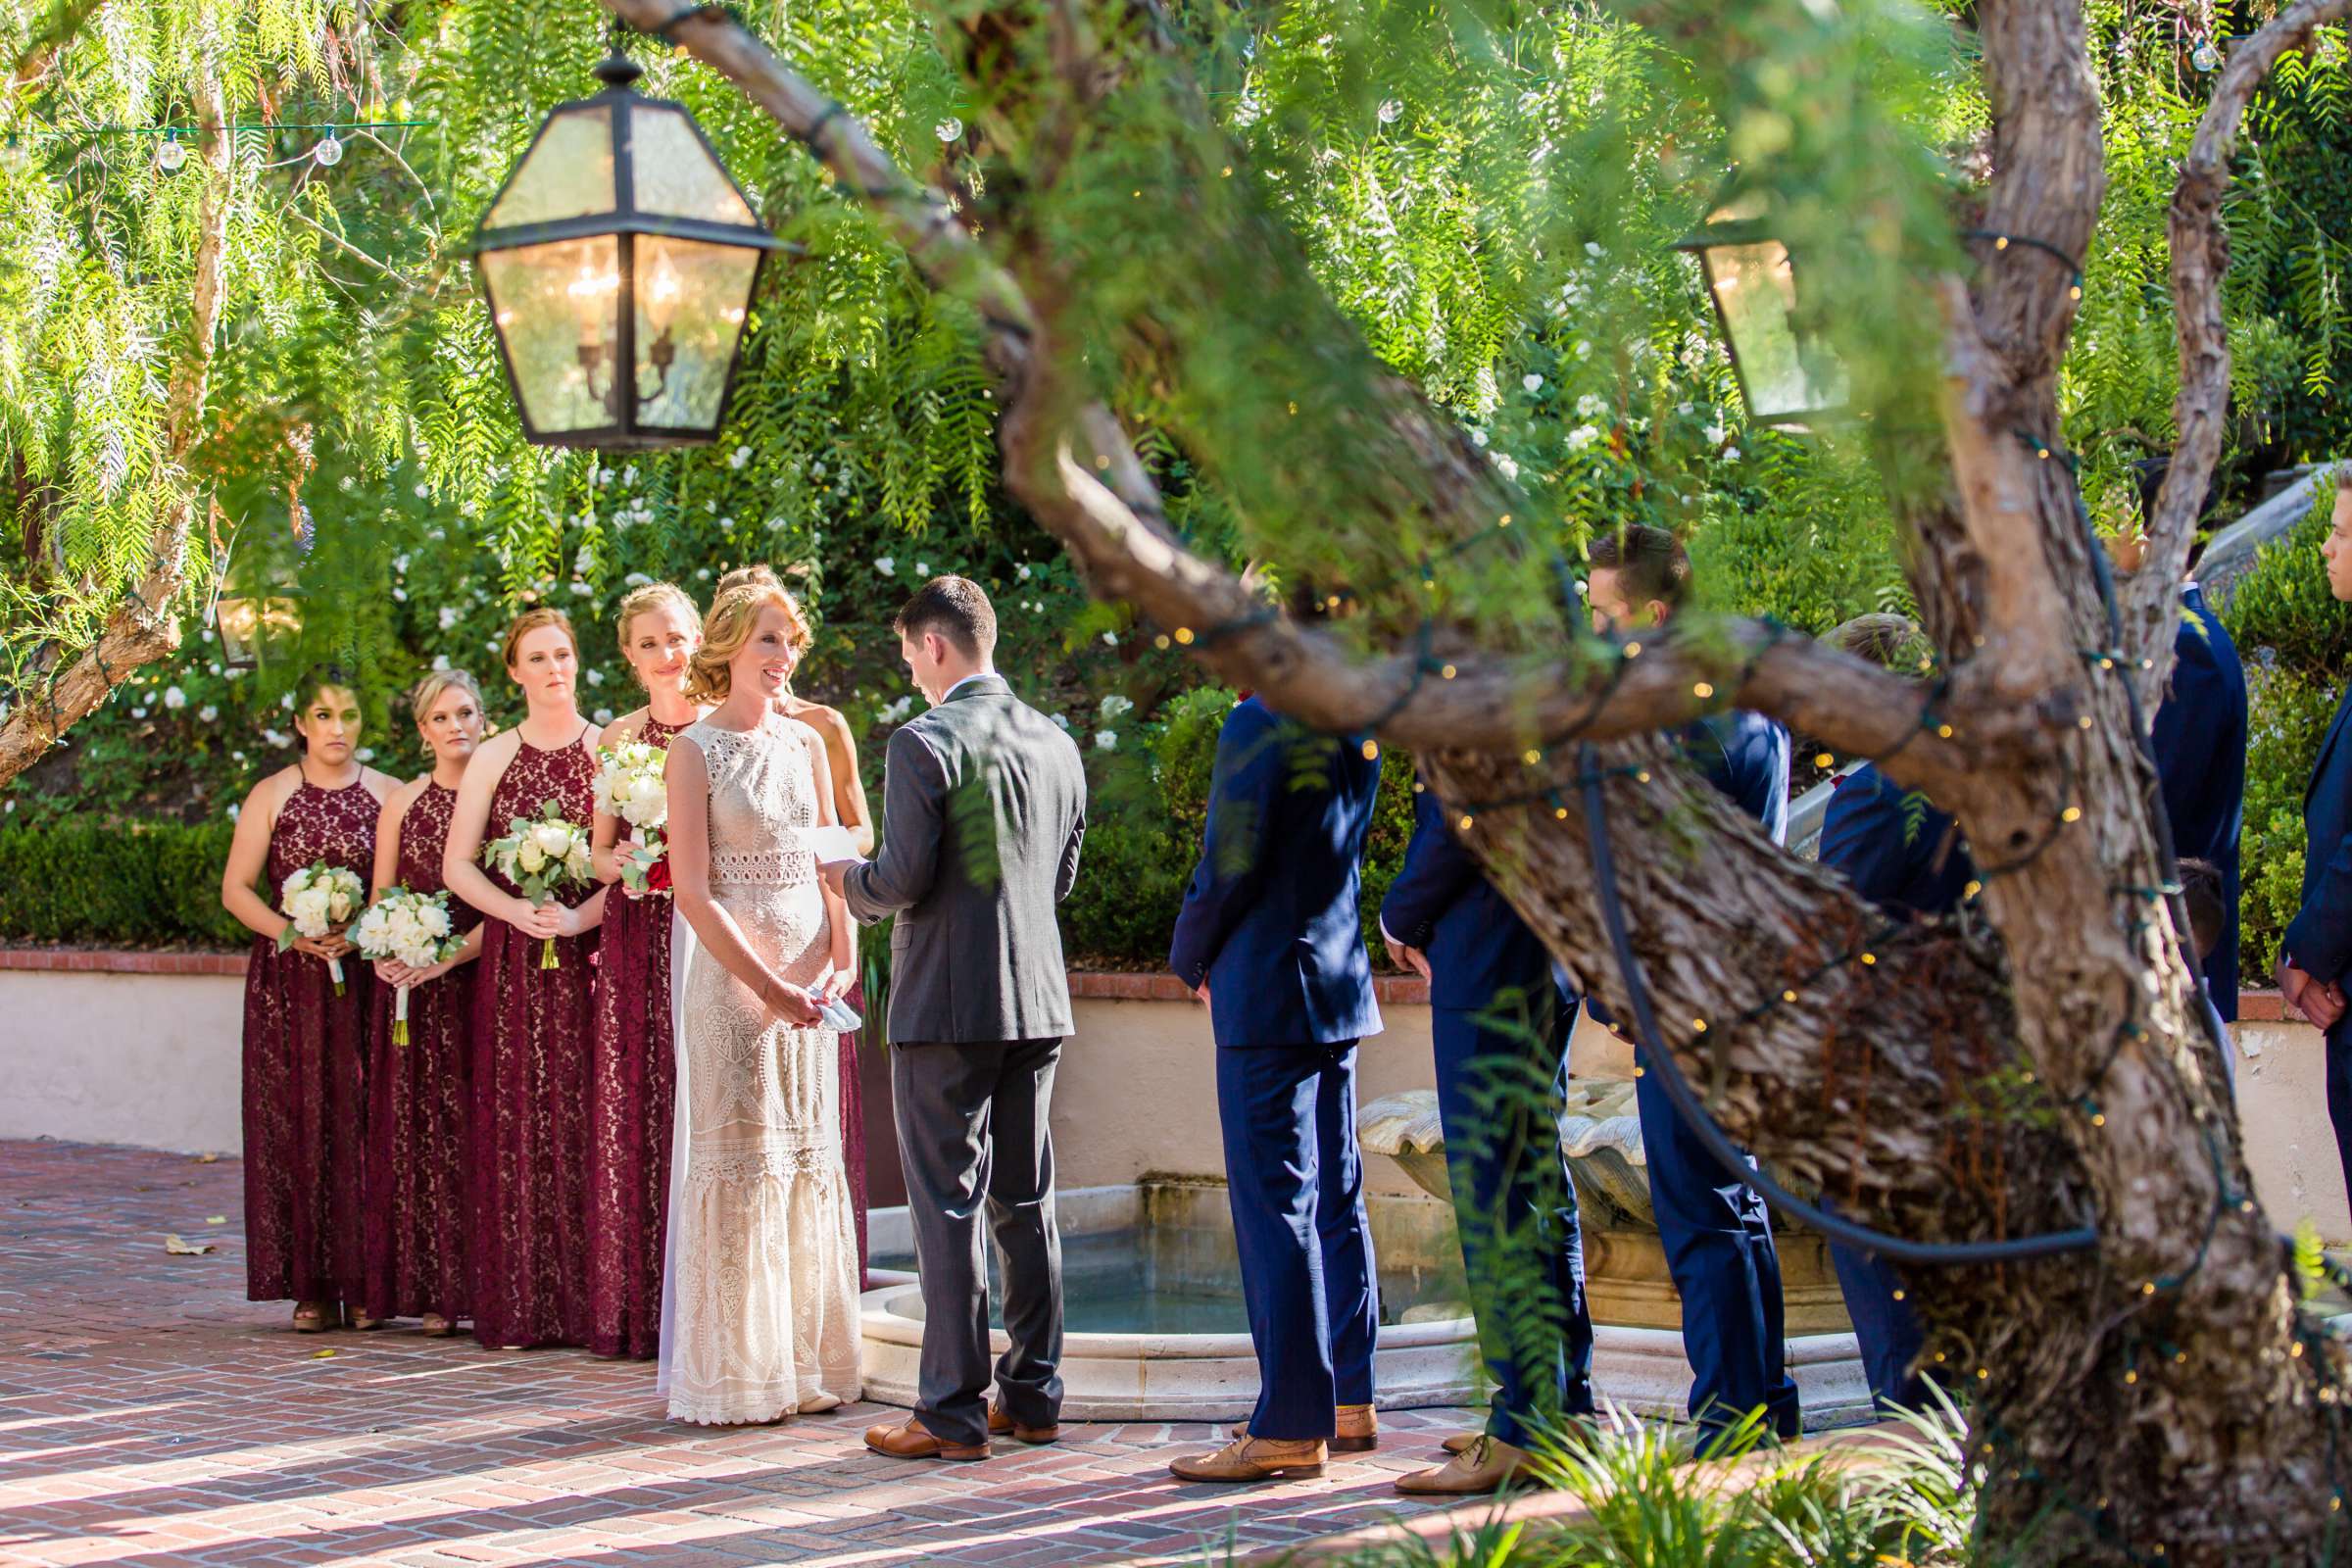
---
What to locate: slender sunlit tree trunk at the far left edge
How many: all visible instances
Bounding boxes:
[0,55,233,785]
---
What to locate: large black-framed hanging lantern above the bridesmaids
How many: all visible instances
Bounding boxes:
[472,49,786,449]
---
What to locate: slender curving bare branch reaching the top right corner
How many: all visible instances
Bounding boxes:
[2117,0,2352,686]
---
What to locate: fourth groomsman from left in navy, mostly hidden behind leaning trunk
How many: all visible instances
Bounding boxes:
[1821,615,1976,1413]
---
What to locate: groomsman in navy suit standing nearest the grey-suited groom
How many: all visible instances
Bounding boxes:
[1169,649,1381,1481]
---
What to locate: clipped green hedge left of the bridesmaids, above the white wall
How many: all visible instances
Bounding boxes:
[0,815,249,948]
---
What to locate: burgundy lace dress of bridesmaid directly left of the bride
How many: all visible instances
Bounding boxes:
[588,714,684,1356]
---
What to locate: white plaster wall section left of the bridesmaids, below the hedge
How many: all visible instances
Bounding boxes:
[0,968,245,1154]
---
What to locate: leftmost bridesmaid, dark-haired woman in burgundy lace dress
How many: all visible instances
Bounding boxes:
[221,665,395,1333]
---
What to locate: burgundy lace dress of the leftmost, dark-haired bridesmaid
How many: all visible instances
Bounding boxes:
[245,780,381,1304]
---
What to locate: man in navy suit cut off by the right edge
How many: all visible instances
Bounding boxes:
[2279,466,2352,1212]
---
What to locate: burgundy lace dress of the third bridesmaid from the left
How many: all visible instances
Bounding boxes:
[466,736,598,1348]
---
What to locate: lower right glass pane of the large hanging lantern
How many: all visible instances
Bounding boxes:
[637,235,760,430]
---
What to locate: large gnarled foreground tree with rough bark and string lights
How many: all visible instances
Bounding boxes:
[607,0,2345,1563]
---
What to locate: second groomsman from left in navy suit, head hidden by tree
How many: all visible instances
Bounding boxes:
[1381,790,1592,1495]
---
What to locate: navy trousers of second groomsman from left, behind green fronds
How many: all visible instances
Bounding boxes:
[1430,1006,1592,1448]
